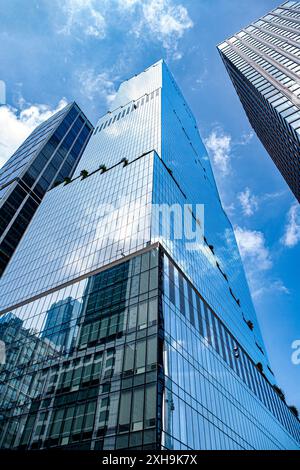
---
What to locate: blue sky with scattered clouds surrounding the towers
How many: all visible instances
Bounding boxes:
[0,0,300,408]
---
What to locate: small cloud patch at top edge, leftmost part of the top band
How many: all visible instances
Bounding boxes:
[59,0,106,39]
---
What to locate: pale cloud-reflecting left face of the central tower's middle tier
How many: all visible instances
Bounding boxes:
[0,154,153,308]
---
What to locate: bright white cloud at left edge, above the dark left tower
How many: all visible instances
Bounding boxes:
[0,99,67,167]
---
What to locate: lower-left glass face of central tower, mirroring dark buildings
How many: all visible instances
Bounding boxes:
[0,249,162,449]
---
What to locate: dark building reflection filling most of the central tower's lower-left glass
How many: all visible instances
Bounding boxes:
[0,258,159,448]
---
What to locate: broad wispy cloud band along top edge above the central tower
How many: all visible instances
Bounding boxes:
[59,0,193,60]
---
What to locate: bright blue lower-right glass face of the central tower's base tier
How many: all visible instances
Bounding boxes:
[162,254,300,450]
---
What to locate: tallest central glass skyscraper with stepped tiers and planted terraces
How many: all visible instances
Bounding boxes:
[0,61,300,449]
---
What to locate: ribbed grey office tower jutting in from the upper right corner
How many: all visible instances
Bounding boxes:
[218,1,300,201]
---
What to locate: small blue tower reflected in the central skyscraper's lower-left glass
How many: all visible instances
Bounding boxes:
[41,297,80,349]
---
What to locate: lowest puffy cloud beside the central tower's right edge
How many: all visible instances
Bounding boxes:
[234,226,272,271]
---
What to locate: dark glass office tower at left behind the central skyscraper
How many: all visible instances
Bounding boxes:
[0,103,93,277]
